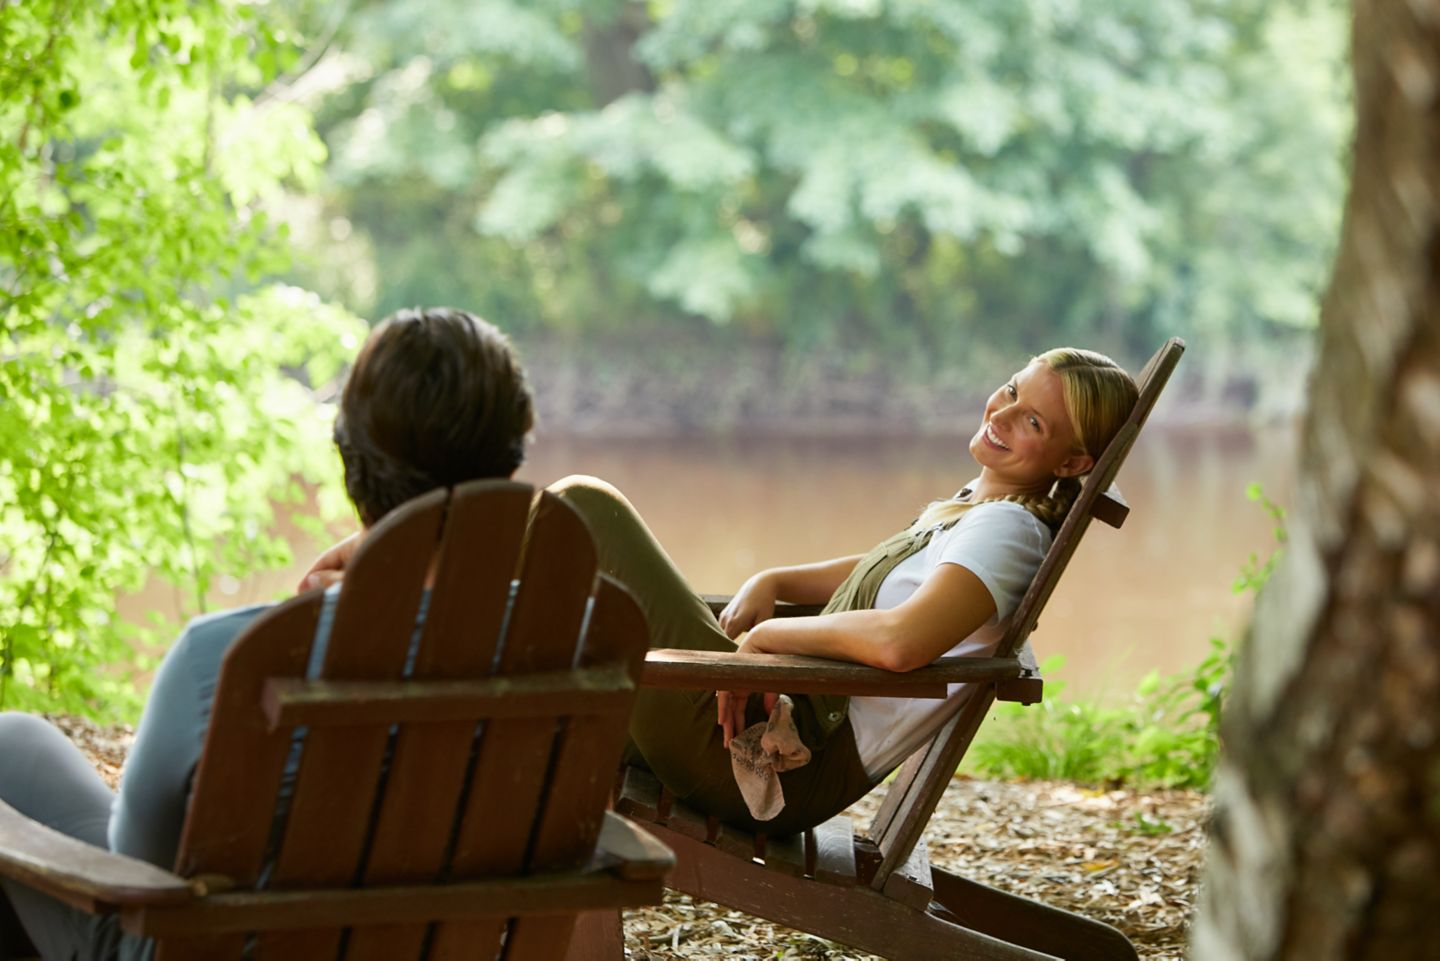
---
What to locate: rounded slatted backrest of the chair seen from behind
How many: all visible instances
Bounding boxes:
[157,481,647,960]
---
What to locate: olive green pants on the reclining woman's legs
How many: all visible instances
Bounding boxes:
[549,477,873,834]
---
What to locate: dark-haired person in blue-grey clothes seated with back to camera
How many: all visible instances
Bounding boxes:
[0,308,534,961]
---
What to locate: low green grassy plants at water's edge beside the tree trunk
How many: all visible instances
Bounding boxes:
[966,484,1286,795]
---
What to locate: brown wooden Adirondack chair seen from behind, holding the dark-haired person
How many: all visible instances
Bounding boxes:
[0,481,674,961]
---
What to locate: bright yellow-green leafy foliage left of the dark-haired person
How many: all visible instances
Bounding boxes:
[0,0,363,716]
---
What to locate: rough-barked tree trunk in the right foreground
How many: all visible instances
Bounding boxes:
[1192,0,1440,961]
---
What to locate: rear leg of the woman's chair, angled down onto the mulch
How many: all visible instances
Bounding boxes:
[930,866,1139,961]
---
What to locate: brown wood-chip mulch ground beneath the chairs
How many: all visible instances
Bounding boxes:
[50,716,1210,961]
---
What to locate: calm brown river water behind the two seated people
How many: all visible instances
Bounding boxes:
[121,425,1293,700]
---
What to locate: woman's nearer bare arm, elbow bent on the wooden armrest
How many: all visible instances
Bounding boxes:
[740,563,995,671]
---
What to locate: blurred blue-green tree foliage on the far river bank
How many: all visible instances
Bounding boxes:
[289,0,1346,383]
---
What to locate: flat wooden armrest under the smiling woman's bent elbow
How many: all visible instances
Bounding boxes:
[641,648,1028,697]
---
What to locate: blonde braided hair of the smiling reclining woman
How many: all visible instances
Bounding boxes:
[913,347,1140,530]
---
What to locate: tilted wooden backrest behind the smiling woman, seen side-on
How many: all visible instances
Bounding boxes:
[870,337,1185,890]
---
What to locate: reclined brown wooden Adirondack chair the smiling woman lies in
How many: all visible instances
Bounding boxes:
[570,339,1185,961]
